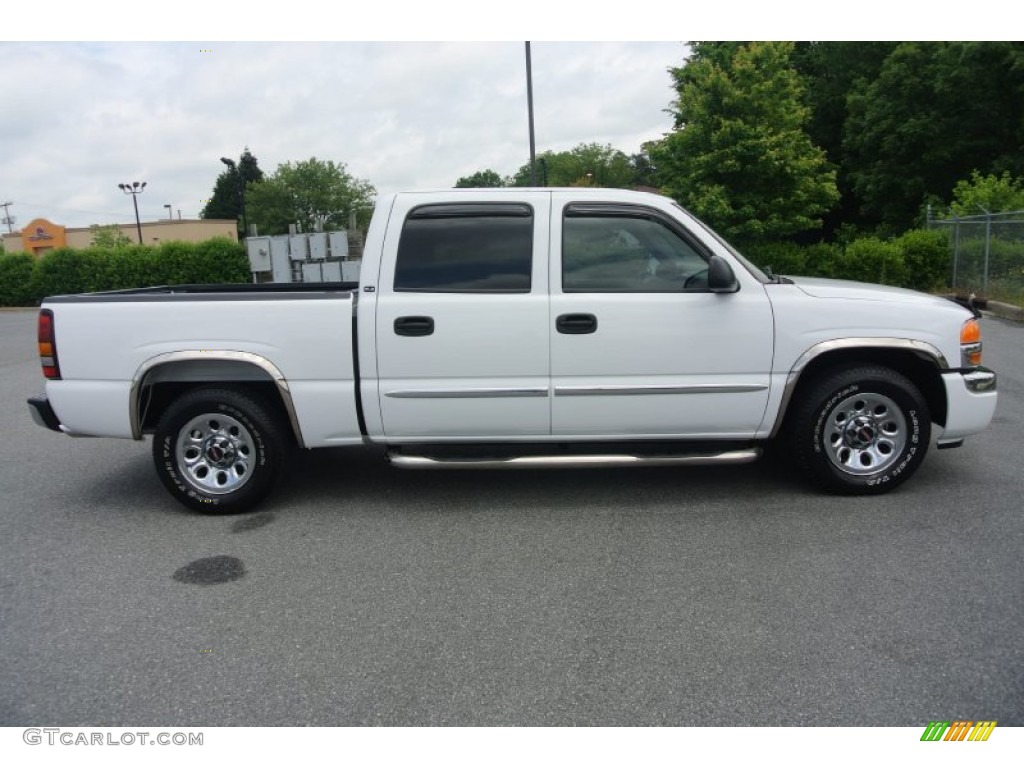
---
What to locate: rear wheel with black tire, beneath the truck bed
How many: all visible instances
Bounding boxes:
[153,388,289,515]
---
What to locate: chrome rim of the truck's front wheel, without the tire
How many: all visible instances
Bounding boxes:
[821,392,907,475]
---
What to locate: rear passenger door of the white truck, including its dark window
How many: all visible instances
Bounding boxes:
[376,190,551,441]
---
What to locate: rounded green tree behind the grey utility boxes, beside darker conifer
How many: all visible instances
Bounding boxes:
[247,158,377,234]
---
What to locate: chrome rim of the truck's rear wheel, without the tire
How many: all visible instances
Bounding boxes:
[175,414,256,496]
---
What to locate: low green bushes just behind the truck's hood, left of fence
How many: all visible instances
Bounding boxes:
[744,229,952,291]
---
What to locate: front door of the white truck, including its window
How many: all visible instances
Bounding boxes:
[548,191,773,439]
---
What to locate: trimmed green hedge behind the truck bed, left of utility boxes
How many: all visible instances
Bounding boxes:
[0,238,252,306]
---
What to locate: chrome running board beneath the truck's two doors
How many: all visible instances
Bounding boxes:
[387,447,761,469]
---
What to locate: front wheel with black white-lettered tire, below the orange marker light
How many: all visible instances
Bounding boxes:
[788,365,932,495]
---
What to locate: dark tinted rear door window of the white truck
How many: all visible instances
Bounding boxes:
[394,203,534,293]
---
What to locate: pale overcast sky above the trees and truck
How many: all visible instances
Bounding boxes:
[0,42,687,228]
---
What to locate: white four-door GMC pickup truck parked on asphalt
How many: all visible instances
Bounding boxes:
[29,188,996,512]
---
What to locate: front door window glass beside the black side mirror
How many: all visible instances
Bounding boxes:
[562,207,708,293]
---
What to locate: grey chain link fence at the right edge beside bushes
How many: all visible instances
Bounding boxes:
[928,211,1024,304]
